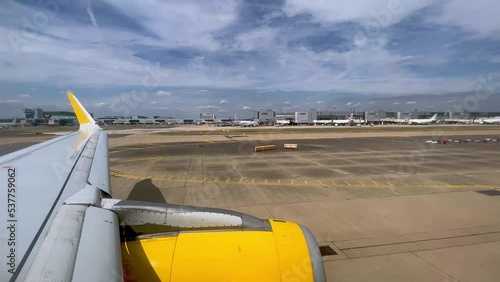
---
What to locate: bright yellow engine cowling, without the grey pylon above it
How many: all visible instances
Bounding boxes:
[121,220,326,282]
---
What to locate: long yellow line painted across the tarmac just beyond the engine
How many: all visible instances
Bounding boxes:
[111,170,500,190]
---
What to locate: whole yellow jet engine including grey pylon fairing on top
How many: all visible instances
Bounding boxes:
[103,200,326,282]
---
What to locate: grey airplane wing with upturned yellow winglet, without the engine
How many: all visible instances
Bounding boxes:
[0,93,122,281]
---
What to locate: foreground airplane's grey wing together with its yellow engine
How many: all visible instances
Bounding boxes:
[0,93,326,281]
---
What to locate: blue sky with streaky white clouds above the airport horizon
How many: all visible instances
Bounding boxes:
[0,0,500,118]
